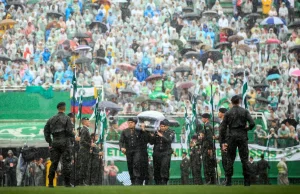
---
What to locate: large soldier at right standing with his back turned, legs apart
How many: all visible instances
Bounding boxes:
[220,95,255,186]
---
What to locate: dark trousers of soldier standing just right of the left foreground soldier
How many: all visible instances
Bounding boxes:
[78,147,90,184]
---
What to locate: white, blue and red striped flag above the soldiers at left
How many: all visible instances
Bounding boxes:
[71,87,98,114]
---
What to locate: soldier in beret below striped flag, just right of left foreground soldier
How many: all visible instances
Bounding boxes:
[78,117,96,186]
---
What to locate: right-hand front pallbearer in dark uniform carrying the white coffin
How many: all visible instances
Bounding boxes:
[150,119,174,185]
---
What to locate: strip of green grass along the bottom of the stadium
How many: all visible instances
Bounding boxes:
[0,185,300,194]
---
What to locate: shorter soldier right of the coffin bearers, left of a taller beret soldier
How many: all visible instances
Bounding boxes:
[190,132,204,185]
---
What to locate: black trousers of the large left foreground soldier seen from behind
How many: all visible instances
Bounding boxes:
[48,146,71,185]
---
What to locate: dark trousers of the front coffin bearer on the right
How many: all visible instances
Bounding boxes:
[153,151,171,185]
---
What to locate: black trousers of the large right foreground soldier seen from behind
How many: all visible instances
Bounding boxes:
[226,137,249,181]
